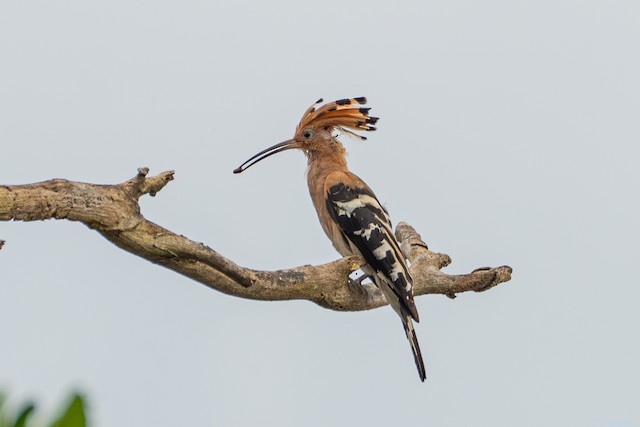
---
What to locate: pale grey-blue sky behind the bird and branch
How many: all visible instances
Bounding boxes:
[0,0,640,427]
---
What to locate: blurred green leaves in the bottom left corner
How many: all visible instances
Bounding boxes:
[0,393,87,427]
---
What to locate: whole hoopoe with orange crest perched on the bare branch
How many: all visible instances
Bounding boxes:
[233,97,426,382]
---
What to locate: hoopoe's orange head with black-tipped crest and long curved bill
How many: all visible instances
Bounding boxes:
[233,97,378,173]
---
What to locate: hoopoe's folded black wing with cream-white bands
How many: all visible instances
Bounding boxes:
[327,183,418,321]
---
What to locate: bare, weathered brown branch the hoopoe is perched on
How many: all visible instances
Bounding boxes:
[0,168,511,311]
